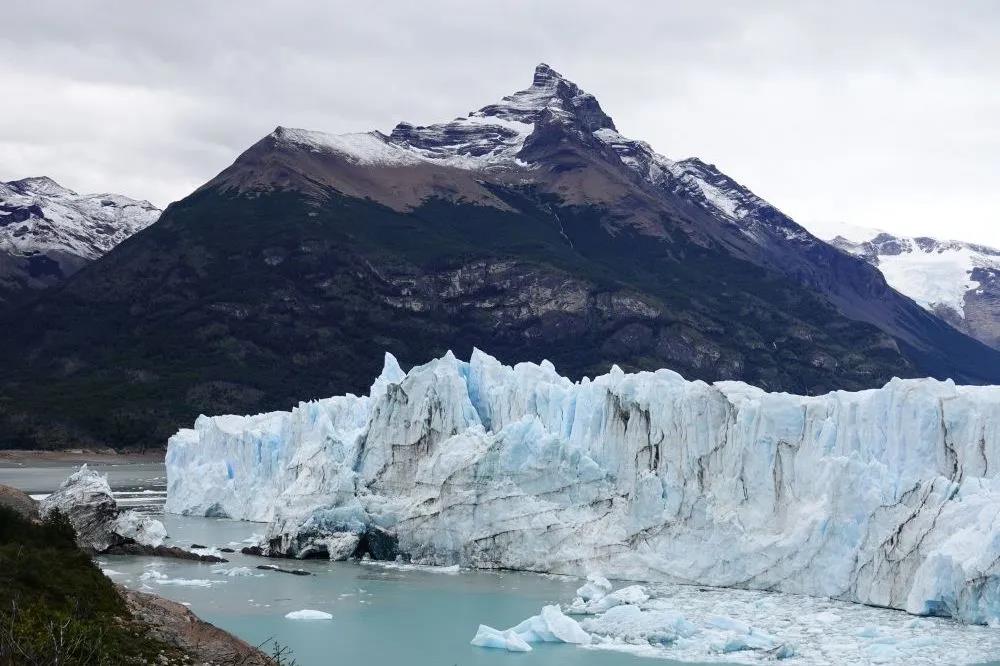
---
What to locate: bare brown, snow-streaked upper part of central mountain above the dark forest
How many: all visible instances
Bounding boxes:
[205,64,1000,374]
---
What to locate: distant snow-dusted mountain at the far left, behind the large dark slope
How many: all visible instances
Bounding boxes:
[0,176,160,303]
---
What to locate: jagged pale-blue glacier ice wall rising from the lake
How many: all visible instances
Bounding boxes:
[167,351,1000,623]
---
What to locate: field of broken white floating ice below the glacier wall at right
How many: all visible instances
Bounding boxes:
[578,585,1000,666]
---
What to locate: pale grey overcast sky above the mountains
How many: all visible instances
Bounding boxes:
[0,0,1000,246]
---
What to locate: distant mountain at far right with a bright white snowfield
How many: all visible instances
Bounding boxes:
[816,223,1000,349]
